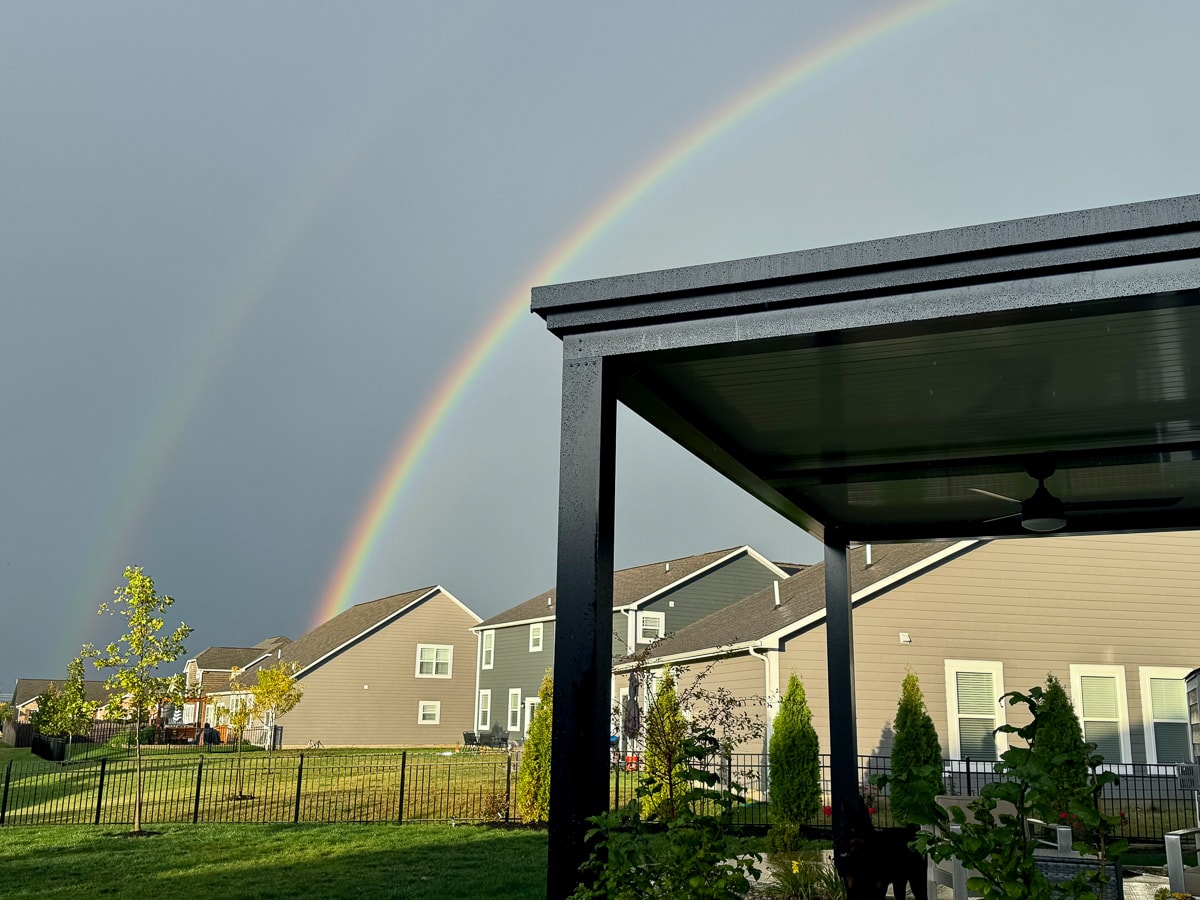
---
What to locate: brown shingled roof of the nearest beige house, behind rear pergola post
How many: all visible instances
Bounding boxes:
[633,541,980,659]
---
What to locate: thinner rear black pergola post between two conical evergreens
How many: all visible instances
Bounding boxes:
[824,528,858,840]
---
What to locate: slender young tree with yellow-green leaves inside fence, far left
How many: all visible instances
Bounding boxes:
[83,566,192,834]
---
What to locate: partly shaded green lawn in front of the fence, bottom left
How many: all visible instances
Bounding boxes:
[0,826,546,900]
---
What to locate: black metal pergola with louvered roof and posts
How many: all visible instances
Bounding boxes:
[533,196,1200,898]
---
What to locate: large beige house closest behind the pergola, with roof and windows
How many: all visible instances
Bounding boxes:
[623,532,1200,764]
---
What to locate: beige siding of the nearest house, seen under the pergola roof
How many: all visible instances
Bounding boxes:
[779,532,1200,762]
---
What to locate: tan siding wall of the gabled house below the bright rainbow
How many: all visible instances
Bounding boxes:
[278,593,478,748]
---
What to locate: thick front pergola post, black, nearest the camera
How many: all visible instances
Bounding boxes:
[546,359,617,900]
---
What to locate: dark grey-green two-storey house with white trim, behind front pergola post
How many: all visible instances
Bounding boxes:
[473,547,803,742]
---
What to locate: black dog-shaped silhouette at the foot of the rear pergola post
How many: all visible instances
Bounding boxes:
[833,800,928,900]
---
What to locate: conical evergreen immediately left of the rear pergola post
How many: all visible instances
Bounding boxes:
[769,672,821,850]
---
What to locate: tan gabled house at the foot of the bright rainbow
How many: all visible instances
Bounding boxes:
[226,586,479,748]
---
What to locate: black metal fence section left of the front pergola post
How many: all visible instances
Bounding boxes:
[0,748,516,826]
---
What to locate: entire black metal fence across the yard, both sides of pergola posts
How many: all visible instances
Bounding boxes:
[0,745,1196,842]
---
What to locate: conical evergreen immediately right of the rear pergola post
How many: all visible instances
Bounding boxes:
[889,670,946,824]
